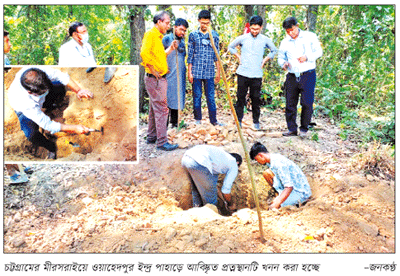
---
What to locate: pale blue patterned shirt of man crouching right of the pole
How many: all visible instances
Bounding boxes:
[270,153,311,197]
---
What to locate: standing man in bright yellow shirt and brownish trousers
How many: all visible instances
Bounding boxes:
[140,11,178,151]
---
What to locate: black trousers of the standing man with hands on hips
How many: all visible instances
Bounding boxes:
[235,74,262,124]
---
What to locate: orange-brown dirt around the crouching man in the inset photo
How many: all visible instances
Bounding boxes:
[4,66,138,162]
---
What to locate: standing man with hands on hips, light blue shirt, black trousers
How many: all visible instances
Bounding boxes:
[228,15,277,130]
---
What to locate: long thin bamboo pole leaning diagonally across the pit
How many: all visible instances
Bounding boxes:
[208,28,265,242]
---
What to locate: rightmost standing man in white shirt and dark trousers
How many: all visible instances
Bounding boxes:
[278,17,322,138]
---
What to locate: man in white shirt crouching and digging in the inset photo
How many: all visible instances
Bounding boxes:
[8,67,93,159]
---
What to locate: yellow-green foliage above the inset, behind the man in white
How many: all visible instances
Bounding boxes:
[4,5,130,65]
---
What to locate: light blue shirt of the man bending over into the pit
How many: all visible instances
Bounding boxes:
[185,145,239,194]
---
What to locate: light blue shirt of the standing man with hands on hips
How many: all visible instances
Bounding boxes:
[228,33,278,78]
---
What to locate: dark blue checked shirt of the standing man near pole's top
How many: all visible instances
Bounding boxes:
[187,30,219,79]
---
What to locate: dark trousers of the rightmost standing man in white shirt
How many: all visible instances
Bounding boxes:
[285,70,316,132]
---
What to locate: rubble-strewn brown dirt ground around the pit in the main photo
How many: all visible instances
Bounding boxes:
[4,106,395,253]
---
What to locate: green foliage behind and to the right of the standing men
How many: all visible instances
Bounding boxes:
[187,5,395,144]
